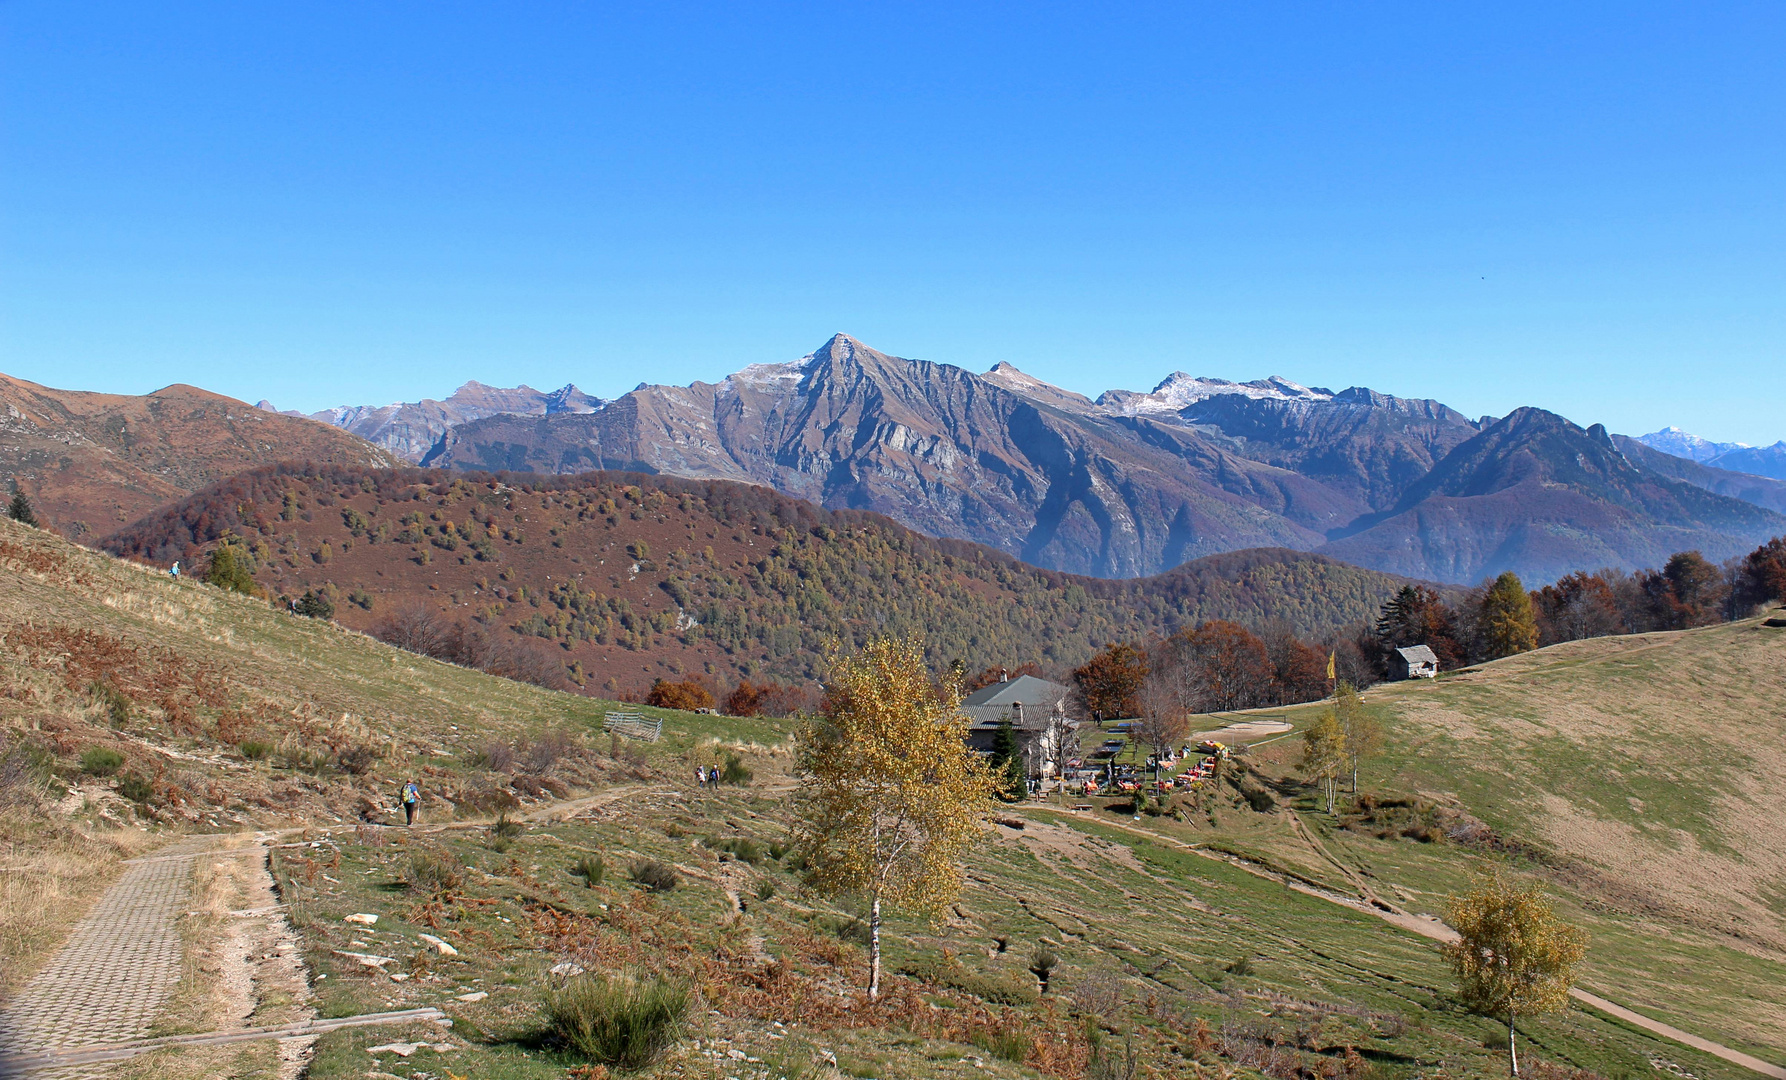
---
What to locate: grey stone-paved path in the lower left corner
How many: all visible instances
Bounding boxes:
[0,837,211,1078]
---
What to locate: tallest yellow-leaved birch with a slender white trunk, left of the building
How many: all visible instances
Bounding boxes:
[797,637,998,998]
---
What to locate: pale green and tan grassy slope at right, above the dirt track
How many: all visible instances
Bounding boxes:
[1228,619,1786,1059]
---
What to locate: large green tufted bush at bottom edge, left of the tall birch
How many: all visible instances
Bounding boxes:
[543,975,688,1069]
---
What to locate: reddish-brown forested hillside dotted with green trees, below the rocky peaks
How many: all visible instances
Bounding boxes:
[107,466,1404,693]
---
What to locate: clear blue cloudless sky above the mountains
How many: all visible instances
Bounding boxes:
[0,0,1786,443]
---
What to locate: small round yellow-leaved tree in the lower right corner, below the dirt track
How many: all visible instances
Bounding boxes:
[1445,871,1588,1076]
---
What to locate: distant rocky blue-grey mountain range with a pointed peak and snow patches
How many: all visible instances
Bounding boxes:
[373,334,1786,582]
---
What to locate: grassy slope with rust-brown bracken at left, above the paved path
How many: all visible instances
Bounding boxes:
[0,518,696,993]
